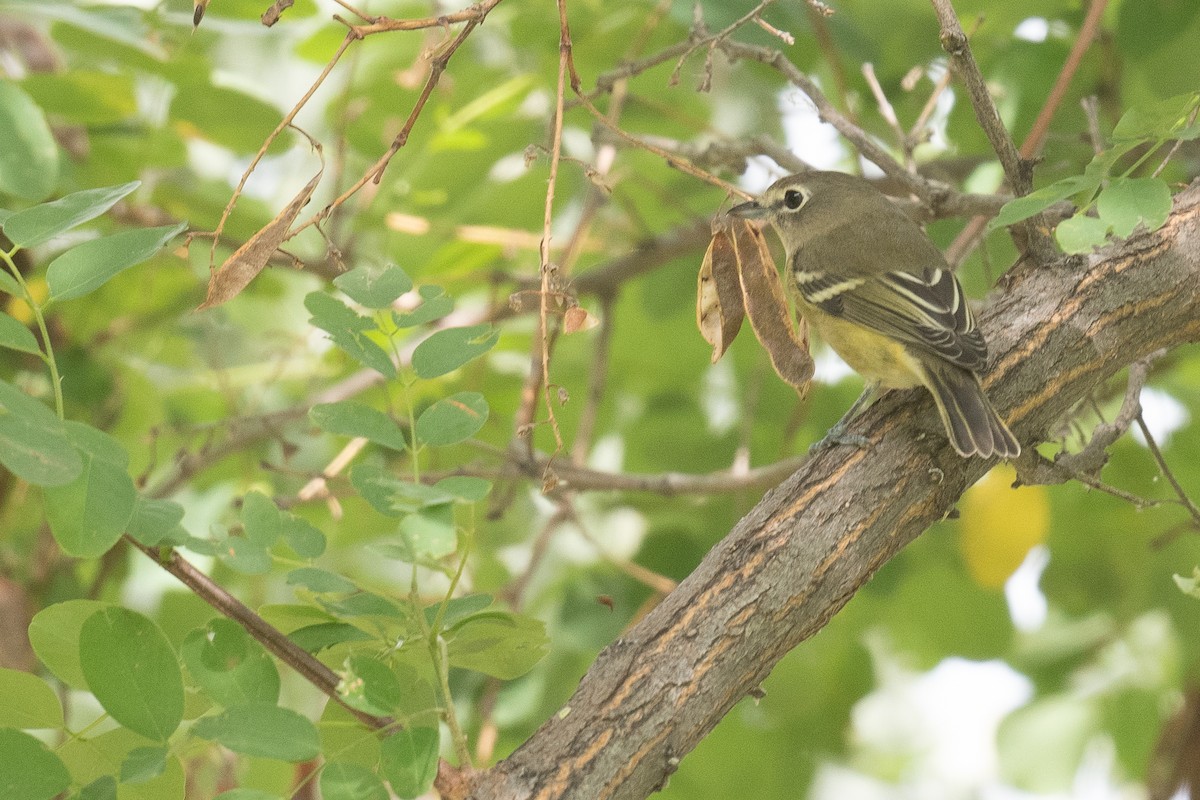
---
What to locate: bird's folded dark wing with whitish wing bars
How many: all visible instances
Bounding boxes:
[793,267,988,372]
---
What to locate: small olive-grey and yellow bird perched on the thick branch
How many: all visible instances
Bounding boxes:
[728,172,1021,458]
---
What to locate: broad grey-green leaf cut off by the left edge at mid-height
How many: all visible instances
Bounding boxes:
[0,380,83,486]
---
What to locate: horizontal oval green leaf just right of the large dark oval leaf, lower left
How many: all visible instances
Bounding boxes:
[192,703,320,762]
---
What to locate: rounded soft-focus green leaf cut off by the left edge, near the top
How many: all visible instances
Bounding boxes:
[0,80,59,201]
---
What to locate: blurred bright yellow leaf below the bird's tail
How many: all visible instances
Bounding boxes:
[959,464,1050,589]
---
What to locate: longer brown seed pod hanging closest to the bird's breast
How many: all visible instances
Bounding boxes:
[731,219,814,397]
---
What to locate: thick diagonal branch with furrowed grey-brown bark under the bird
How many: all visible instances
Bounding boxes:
[470,184,1200,800]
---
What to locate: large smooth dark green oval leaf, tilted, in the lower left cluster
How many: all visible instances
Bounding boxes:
[79,607,184,741]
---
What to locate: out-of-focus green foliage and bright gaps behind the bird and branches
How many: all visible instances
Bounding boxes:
[0,0,1200,800]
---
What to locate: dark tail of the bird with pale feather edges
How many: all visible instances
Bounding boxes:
[924,363,1021,458]
